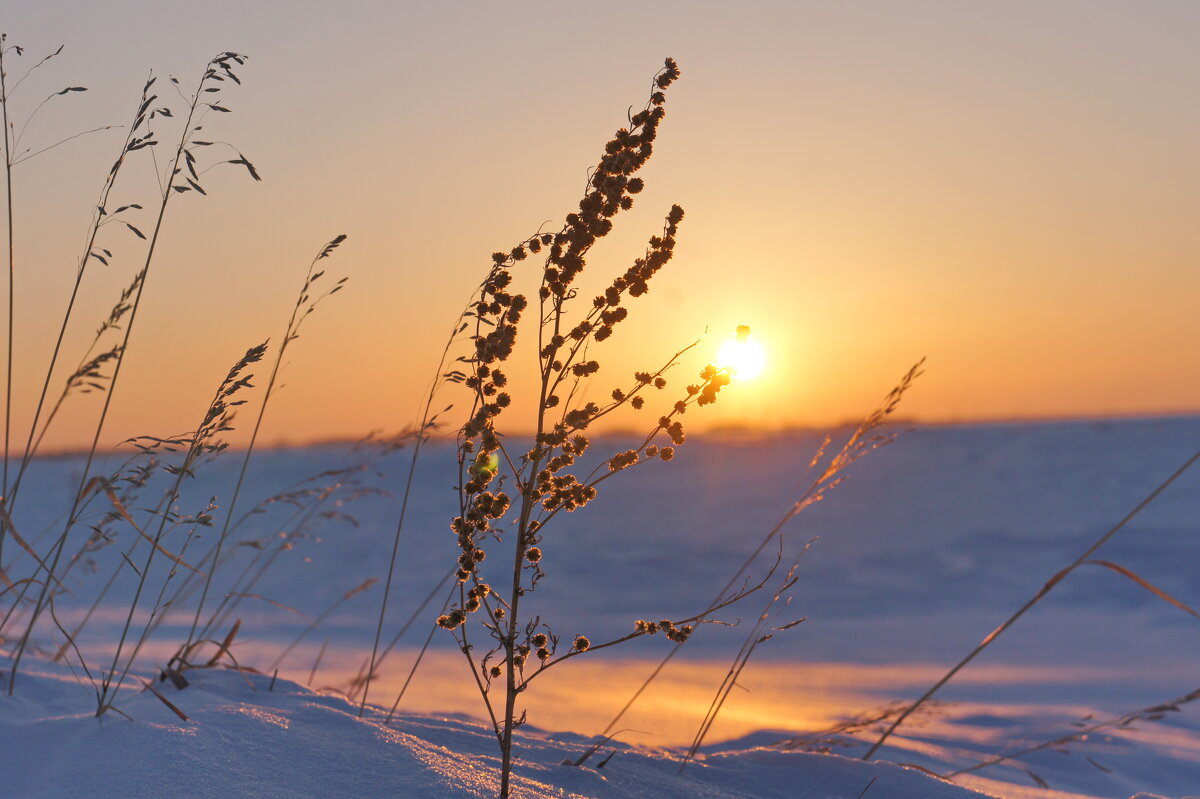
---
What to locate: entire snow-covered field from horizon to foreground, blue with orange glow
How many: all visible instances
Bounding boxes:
[0,419,1200,799]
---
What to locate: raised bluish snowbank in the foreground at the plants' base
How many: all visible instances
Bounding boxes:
[0,657,980,799]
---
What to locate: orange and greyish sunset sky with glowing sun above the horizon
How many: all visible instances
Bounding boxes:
[0,0,1200,449]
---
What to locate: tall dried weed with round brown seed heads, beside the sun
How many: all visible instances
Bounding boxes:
[437,59,744,797]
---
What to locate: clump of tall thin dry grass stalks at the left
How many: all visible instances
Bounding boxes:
[0,36,360,715]
